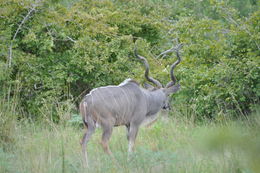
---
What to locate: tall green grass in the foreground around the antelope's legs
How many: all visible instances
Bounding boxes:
[0,112,260,173]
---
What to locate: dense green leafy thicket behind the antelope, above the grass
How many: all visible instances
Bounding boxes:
[0,0,260,122]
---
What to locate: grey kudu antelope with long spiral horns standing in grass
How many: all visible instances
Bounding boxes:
[79,44,181,164]
